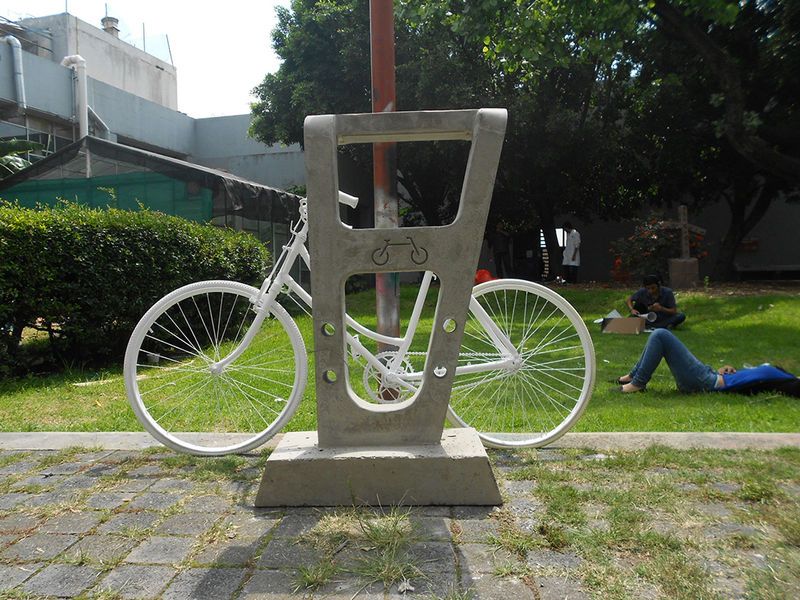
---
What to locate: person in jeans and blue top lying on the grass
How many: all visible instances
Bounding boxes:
[617,329,800,398]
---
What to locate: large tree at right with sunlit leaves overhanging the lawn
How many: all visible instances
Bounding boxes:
[422,0,800,278]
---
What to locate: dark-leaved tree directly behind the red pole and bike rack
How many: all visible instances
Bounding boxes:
[251,0,640,246]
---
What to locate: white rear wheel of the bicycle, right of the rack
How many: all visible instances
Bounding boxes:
[448,279,595,448]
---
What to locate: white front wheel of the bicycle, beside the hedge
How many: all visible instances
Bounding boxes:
[124,281,308,456]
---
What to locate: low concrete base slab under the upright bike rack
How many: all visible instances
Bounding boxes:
[255,428,502,507]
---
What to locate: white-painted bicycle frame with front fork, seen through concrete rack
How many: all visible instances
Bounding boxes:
[210,200,519,390]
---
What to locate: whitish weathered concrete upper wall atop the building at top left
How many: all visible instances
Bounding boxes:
[20,14,178,110]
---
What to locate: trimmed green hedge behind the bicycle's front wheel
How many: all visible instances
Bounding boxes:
[0,201,269,375]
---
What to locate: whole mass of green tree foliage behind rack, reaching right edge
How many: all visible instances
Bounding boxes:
[252,0,800,277]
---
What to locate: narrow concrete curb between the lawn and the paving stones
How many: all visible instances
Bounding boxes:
[0,431,800,450]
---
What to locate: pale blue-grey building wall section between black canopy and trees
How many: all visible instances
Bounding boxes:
[194,115,306,189]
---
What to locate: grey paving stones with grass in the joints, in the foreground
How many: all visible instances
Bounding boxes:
[0,448,800,600]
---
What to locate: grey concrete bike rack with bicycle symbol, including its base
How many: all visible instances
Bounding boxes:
[256,109,507,506]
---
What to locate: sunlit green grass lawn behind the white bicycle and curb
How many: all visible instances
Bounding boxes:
[0,286,800,432]
